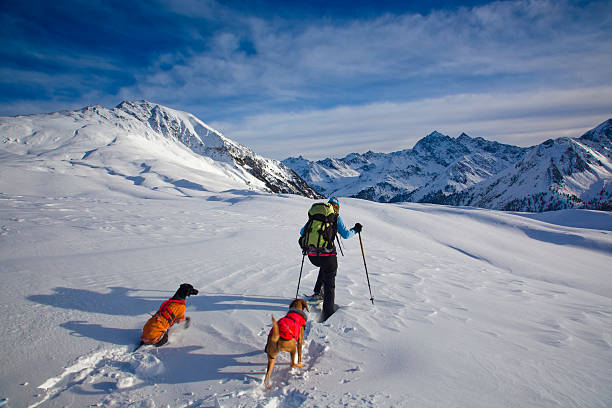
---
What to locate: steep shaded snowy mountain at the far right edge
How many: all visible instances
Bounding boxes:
[444,119,612,212]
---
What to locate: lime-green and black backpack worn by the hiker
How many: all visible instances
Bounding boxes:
[298,203,338,255]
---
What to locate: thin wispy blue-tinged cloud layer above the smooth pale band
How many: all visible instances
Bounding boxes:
[113,0,612,120]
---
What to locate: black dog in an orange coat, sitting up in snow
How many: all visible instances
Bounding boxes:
[134,283,198,351]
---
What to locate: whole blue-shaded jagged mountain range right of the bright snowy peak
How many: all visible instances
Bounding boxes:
[283,119,612,212]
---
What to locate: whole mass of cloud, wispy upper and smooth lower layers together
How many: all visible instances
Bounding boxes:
[0,0,612,163]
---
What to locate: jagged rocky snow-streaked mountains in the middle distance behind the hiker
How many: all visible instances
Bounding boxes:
[283,132,527,202]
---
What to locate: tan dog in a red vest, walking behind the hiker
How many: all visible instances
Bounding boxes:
[264,299,310,389]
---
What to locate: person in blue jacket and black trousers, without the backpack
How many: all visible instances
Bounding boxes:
[300,197,362,321]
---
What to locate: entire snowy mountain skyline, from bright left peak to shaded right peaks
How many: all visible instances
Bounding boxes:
[0,101,612,212]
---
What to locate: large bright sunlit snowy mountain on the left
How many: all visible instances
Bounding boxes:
[0,101,319,198]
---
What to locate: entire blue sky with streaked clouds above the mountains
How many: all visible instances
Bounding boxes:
[0,0,612,159]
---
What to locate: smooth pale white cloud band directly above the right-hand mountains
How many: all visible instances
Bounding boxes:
[210,86,612,159]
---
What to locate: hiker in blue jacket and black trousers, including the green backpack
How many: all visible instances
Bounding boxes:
[300,197,362,320]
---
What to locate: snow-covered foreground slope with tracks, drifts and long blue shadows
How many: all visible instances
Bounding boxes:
[0,192,612,407]
